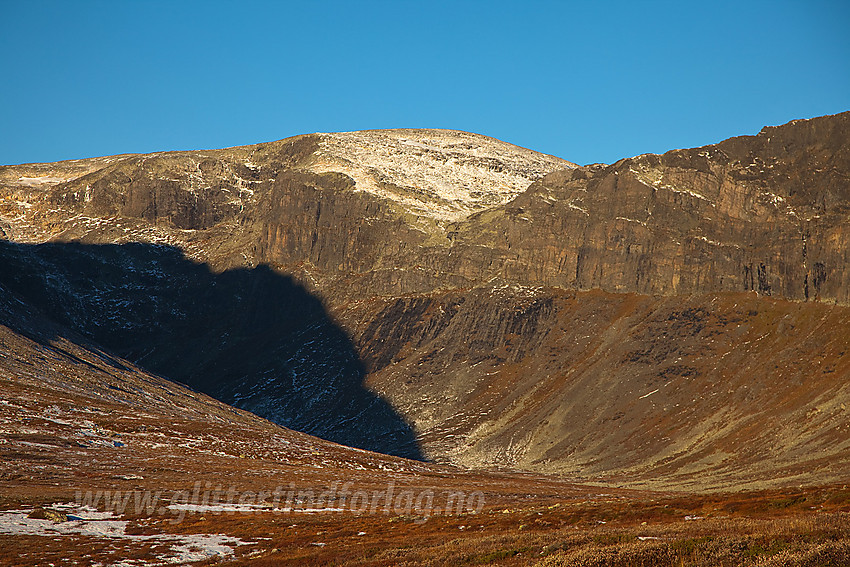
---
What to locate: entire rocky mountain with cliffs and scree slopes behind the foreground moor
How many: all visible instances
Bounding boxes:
[0,113,850,485]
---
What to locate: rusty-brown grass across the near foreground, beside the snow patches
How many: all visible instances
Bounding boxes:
[0,487,836,567]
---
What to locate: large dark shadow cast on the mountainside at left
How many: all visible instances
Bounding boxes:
[0,241,424,460]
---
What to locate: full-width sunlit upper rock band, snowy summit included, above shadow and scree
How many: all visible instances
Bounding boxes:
[2,118,850,303]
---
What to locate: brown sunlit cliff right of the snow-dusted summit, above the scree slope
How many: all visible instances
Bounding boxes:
[448,114,850,303]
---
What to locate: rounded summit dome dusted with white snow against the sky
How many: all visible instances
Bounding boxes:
[310,129,576,221]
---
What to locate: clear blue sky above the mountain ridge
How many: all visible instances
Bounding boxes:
[0,0,850,164]
